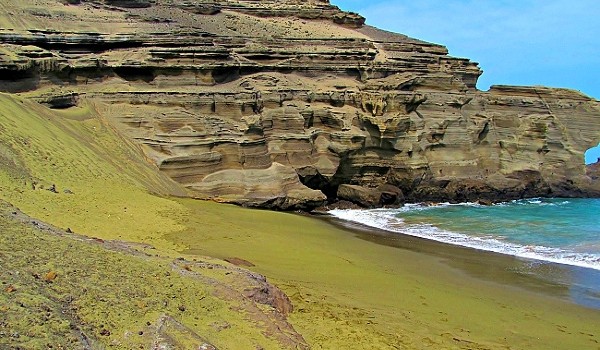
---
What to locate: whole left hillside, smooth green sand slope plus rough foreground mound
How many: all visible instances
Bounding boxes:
[0,94,304,349]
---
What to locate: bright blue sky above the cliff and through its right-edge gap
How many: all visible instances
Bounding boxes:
[331,0,600,163]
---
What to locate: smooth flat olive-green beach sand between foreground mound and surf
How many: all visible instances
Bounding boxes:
[167,200,600,349]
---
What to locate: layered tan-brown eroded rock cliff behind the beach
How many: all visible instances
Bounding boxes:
[0,0,600,209]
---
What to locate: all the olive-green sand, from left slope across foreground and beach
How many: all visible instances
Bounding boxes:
[0,94,600,349]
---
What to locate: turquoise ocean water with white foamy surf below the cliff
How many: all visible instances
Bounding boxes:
[330,198,600,270]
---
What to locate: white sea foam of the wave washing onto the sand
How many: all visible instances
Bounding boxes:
[329,206,600,270]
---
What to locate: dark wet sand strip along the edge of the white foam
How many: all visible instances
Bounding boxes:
[314,214,600,310]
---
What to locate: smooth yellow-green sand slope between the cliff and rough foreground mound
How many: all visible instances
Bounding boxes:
[0,94,190,250]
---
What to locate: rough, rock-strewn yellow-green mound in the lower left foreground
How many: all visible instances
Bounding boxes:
[0,201,292,349]
